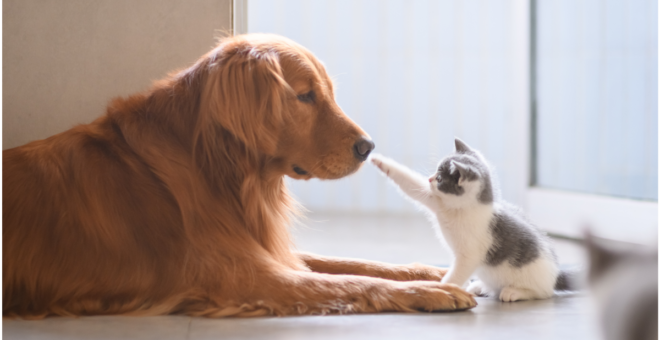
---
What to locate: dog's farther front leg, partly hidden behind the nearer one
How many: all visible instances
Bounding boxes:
[298,253,447,281]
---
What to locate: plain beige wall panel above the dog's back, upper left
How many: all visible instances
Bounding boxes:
[2,0,231,149]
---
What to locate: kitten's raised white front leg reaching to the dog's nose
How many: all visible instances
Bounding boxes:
[371,154,433,207]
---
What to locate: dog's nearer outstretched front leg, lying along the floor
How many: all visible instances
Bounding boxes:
[201,270,476,317]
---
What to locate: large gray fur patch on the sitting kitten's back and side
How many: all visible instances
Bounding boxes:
[486,208,545,268]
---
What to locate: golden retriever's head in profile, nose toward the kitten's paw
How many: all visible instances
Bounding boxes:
[201,34,374,179]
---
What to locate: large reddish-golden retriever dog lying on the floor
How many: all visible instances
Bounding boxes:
[2,35,476,318]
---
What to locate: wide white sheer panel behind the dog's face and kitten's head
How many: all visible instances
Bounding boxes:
[248,0,528,212]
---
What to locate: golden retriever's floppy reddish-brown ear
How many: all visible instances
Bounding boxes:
[200,47,291,154]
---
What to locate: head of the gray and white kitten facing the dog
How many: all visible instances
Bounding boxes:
[429,138,493,207]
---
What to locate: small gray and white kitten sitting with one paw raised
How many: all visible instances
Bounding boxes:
[371,138,568,301]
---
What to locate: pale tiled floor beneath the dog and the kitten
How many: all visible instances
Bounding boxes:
[3,214,599,340]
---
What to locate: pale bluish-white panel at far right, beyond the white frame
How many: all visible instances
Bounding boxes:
[537,0,658,201]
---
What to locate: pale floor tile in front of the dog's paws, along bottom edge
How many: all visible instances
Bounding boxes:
[190,295,599,340]
